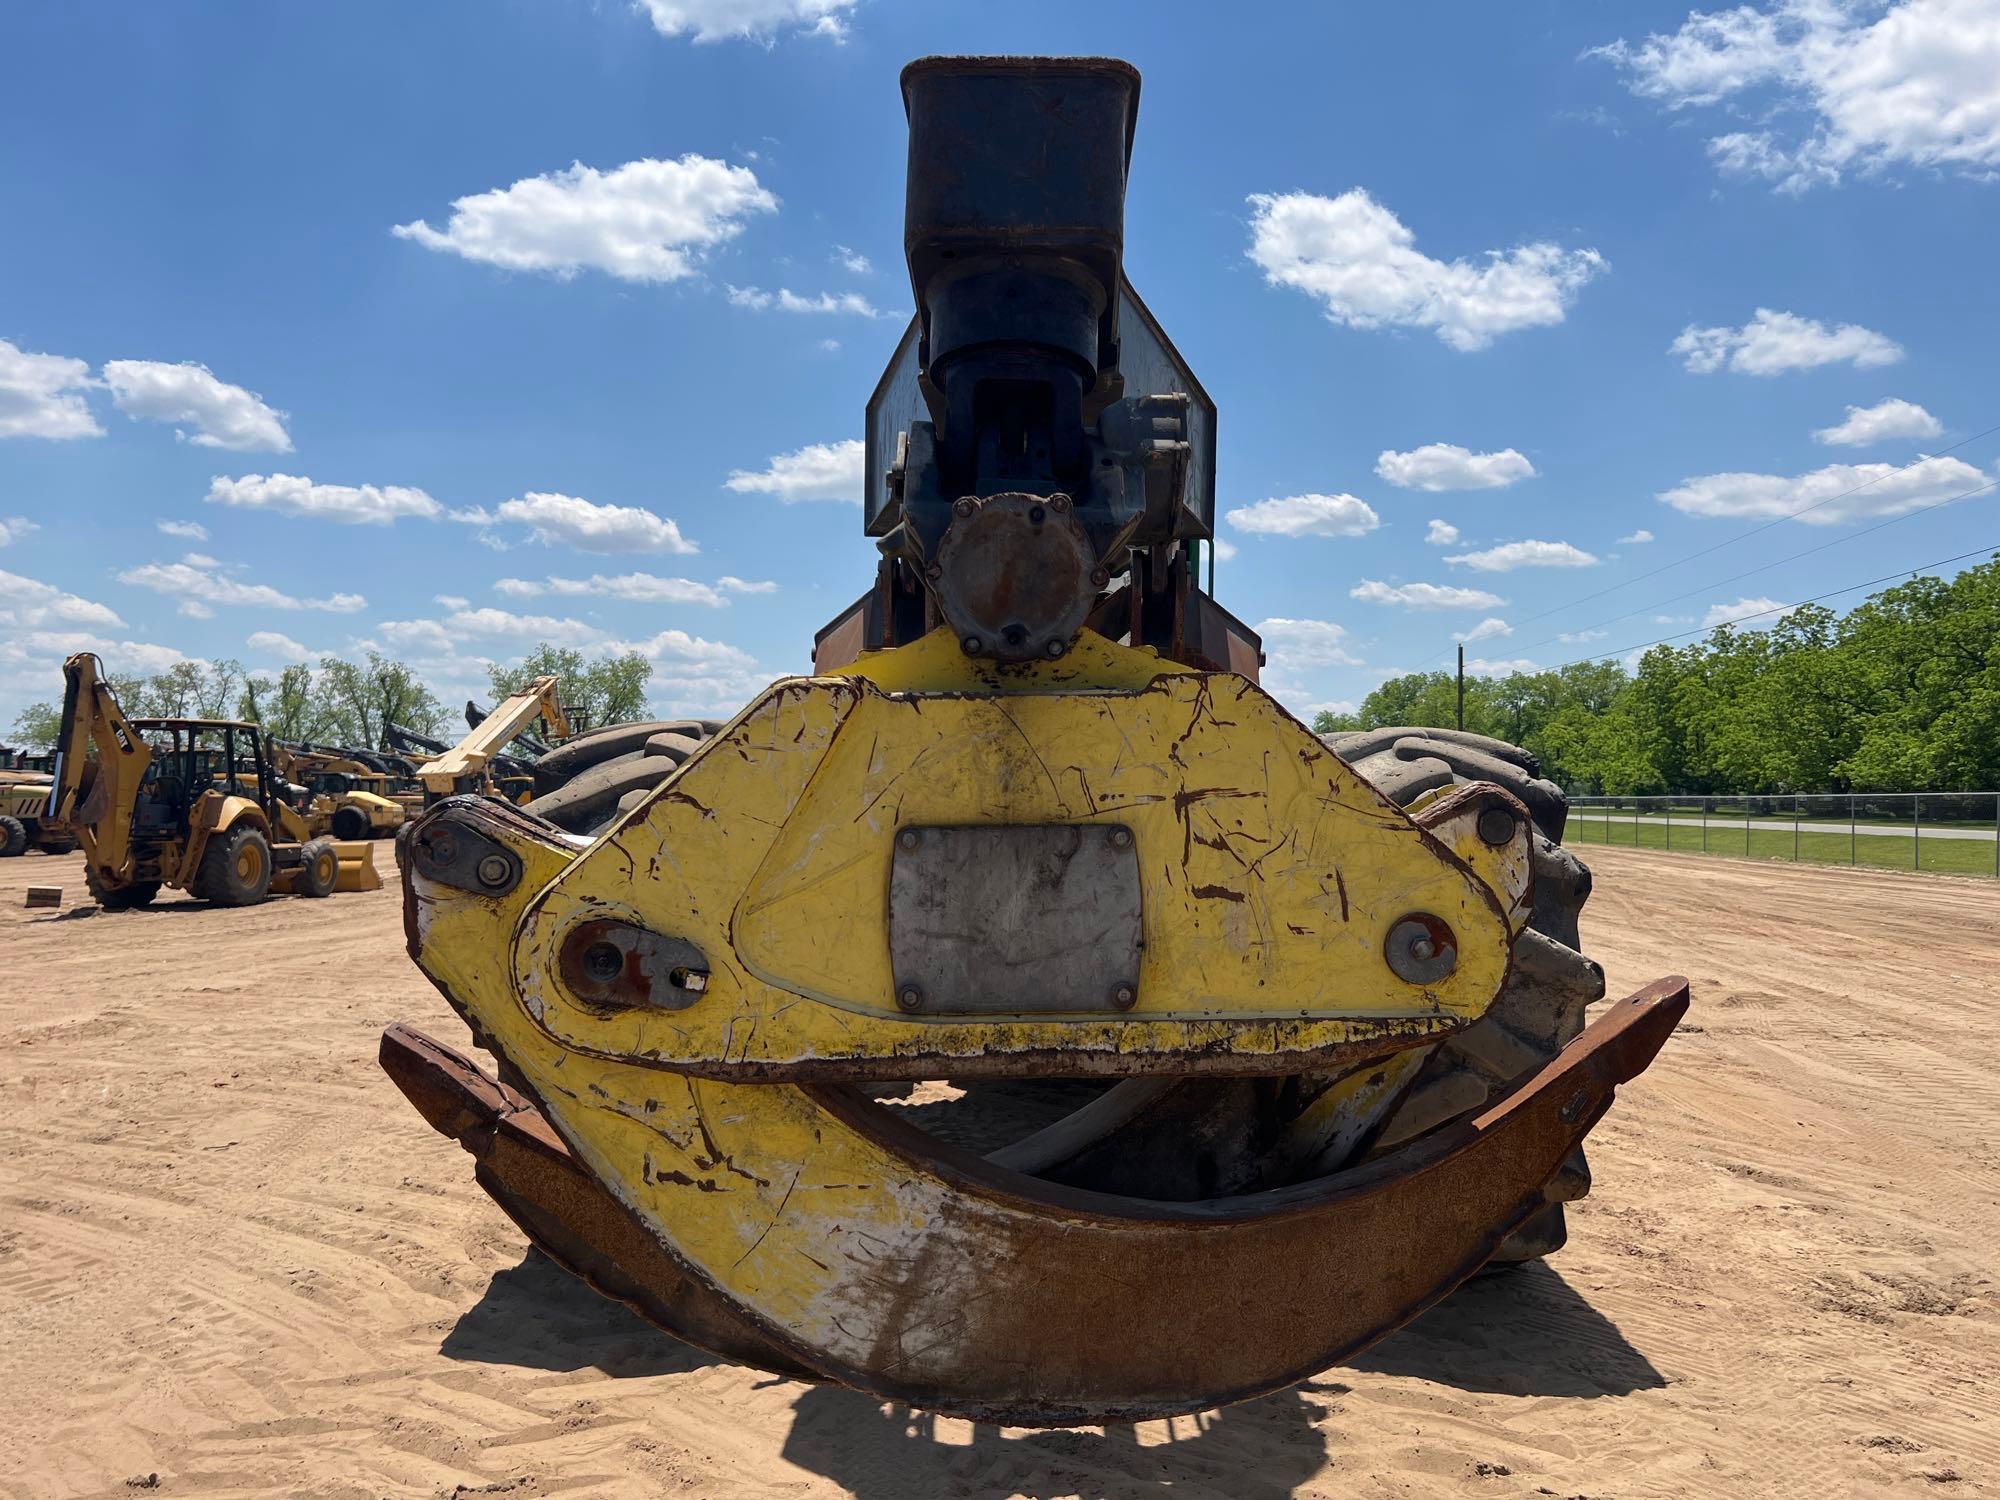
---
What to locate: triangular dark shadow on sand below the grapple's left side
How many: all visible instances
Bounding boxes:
[438,1248,716,1380]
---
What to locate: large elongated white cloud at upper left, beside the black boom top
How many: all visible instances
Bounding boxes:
[392,154,778,282]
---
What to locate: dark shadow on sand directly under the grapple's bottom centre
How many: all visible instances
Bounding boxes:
[784,1386,1326,1500]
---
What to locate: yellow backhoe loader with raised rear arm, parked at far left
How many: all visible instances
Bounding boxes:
[44,652,382,910]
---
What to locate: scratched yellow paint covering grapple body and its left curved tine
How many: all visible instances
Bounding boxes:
[412,640,1508,1366]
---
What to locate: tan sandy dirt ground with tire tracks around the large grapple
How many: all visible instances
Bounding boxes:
[0,848,2000,1500]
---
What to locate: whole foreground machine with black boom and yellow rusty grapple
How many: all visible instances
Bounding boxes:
[380,58,1686,1426]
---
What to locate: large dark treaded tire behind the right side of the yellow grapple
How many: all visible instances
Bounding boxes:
[1324,728,1604,1268]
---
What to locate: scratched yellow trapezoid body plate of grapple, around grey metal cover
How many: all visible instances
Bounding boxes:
[514,632,1512,1066]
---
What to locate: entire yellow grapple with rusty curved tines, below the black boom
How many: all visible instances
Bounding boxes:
[382,632,1686,1426]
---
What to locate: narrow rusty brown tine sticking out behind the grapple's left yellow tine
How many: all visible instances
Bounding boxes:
[378,1026,820,1380]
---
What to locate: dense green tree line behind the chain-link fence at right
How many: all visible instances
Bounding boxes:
[1314,556,2000,796]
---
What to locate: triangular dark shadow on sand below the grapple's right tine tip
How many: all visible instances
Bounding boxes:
[1352,1260,1666,1398]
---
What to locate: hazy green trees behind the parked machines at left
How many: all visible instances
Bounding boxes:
[14,644,652,750]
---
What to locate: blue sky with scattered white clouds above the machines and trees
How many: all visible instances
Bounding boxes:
[0,0,2000,726]
